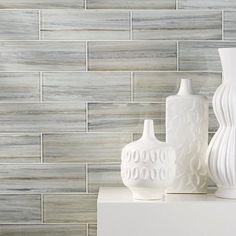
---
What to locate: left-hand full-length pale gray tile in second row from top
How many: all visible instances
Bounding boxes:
[41,10,130,40]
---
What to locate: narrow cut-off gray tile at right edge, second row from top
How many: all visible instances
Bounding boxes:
[224,11,236,40]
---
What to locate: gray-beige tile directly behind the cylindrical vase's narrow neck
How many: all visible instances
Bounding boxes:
[134,72,222,102]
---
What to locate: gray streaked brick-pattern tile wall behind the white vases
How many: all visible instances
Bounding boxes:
[0,0,236,236]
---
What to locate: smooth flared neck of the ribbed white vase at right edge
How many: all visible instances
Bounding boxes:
[219,48,236,85]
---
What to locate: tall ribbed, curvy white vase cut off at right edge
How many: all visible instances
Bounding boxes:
[208,48,236,199]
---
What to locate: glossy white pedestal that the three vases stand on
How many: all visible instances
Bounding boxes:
[98,188,236,236]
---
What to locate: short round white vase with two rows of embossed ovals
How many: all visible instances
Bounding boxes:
[121,120,175,200]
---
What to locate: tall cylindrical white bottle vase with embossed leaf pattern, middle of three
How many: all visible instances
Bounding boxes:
[166,79,208,193]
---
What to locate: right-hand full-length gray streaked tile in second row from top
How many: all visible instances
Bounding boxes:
[133,10,222,40]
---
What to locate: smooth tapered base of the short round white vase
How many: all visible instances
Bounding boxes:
[130,188,164,201]
